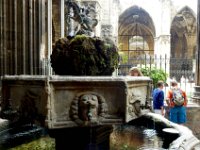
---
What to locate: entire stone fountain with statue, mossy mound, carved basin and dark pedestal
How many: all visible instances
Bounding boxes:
[1,0,199,150]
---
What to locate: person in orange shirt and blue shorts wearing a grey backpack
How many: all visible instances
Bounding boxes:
[166,80,188,124]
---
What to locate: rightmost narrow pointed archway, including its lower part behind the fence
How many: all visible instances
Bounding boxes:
[170,6,197,80]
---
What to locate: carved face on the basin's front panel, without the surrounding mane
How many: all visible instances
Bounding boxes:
[79,94,98,121]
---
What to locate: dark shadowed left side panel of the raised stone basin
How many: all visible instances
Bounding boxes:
[1,76,48,125]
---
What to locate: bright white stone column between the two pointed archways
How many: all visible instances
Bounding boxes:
[154,0,171,74]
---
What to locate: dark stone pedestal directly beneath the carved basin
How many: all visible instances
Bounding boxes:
[49,126,113,150]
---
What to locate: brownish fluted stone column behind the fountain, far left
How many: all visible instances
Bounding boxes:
[0,0,52,76]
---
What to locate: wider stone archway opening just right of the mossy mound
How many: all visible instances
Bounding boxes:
[118,6,155,75]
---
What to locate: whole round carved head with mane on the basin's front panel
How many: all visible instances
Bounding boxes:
[69,92,107,126]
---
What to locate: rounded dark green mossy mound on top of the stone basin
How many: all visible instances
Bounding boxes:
[51,35,119,76]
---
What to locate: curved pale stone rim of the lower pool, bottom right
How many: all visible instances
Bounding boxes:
[128,112,200,150]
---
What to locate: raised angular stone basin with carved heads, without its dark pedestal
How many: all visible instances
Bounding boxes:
[1,75,152,129]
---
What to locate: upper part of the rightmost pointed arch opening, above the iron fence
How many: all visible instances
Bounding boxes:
[170,6,197,58]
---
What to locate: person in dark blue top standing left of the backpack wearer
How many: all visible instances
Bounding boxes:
[152,81,165,116]
